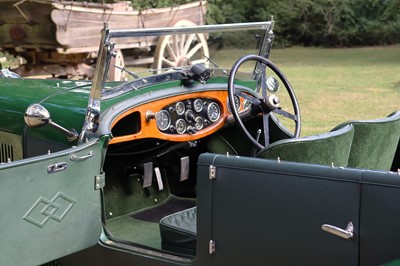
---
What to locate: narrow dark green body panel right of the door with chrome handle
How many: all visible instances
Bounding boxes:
[360,171,400,266]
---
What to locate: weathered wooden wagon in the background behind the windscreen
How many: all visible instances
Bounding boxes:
[0,0,208,80]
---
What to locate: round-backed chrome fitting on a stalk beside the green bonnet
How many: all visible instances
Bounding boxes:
[24,103,78,141]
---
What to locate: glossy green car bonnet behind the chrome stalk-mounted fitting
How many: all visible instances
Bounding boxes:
[0,79,90,151]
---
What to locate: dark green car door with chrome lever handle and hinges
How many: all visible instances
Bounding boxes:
[197,154,362,265]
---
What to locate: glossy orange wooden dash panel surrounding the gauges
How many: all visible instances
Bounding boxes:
[110,91,229,144]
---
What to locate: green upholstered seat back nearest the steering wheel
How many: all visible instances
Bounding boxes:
[257,125,354,166]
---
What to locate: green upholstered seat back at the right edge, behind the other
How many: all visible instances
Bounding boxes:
[333,111,400,170]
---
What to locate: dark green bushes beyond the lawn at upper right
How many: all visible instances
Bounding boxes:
[208,0,400,47]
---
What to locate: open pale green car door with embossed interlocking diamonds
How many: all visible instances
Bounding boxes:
[0,137,108,265]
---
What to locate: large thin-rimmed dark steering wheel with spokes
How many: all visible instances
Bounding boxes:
[228,55,301,149]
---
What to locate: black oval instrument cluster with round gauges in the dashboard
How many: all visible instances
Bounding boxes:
[155,98,221,135]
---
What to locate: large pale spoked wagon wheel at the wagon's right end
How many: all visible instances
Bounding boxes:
[153,20,210,72]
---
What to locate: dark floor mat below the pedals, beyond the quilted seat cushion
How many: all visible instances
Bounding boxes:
[131,197,196,223]
